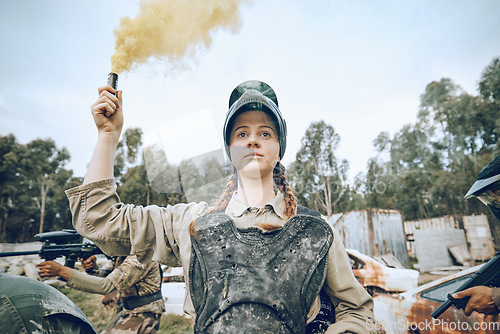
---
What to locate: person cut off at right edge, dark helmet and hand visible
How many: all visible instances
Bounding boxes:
[452,156,500,315]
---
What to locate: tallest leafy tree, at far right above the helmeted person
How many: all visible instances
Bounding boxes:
[420,75,498,216]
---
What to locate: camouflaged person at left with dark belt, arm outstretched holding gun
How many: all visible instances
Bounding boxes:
[37,256,165,334]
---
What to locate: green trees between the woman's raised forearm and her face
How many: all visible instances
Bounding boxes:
[115,129,230,206]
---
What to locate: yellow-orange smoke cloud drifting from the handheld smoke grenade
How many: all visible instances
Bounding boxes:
[111,0,247,74]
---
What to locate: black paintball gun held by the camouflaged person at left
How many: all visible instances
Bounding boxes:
[0,229,105,274]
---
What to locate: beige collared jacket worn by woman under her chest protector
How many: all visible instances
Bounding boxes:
[66,179,374,333]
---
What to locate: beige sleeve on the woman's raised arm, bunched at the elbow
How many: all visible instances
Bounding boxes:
[66,178,207,266]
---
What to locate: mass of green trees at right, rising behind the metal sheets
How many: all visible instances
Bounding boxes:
[364,58,500,231]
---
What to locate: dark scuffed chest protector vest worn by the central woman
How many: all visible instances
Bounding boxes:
[189,207,333,334]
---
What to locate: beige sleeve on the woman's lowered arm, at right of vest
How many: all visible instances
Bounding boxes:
[325,229,377,334]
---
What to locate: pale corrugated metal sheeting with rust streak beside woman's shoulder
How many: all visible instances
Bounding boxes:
[326,209,408,268]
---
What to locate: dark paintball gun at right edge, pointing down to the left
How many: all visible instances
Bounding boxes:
[431,252,500,319]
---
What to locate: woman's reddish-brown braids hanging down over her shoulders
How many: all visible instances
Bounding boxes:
[189,162,297,235]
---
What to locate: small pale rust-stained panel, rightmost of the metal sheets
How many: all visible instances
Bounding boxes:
[462,215,495,261]
